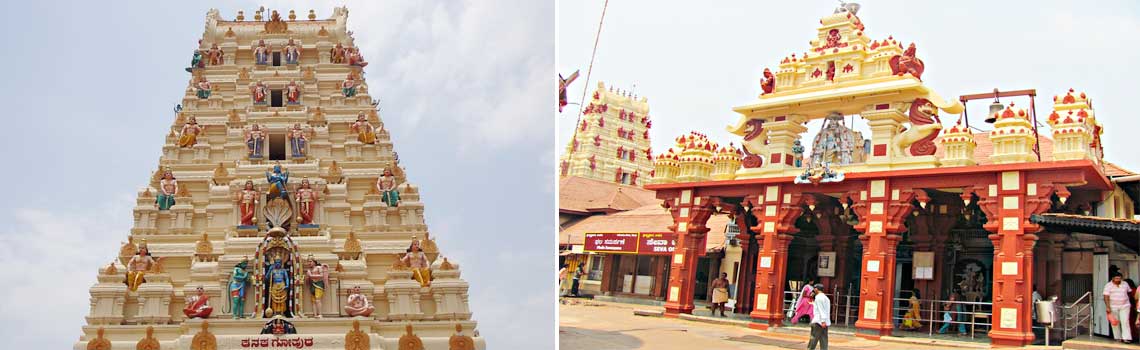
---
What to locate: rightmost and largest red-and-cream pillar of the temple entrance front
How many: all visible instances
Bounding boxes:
[974,171,1053,347]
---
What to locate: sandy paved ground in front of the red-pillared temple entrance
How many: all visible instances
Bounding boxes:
[559,300,962,350]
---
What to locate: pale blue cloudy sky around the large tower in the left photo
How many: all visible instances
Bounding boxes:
[0,0,554,349]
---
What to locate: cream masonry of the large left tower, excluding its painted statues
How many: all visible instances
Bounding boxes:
[75,8,486,349]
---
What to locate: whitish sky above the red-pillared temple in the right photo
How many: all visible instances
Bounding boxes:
[556,0,1140,171]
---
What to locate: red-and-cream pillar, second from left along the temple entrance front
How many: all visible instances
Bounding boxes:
[749,185,803,329]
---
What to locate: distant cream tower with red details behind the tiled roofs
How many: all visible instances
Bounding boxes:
[559,82,653,186]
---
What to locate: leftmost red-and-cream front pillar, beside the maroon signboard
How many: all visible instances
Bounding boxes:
[665,189,715,317]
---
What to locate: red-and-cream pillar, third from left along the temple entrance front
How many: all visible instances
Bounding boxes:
[853,179,914,340]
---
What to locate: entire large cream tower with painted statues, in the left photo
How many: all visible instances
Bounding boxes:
[74,7,486,350]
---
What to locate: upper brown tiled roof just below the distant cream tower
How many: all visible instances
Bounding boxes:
[559,177,660,213]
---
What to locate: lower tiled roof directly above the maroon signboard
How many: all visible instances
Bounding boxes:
[559,201,728,254]
